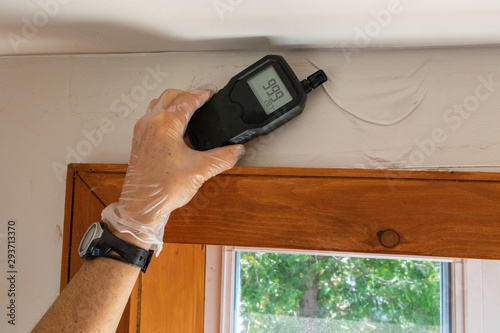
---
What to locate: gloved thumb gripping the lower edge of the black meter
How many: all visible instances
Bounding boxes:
[203,145,245,179]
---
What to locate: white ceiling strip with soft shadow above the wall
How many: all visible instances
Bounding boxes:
[0,0,500,55]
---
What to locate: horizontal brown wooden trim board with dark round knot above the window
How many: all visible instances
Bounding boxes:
[64,164,500,259]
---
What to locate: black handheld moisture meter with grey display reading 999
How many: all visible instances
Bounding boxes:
[186,55,327,150]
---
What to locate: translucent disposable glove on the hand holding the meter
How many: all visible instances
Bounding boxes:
[102,89,245,256]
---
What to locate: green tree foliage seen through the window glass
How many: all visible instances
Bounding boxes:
[240,252,440,333]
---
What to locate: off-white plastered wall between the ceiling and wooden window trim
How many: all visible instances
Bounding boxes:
[0,47,500,332]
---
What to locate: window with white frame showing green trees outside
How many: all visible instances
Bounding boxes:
[219,248,460,333]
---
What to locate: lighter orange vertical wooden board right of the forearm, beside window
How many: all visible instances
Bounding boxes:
[139,243,206,333]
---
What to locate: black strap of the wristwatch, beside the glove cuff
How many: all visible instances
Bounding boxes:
[98,222,154,273]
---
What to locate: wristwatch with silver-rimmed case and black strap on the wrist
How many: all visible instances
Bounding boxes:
[78,222,154,272]
